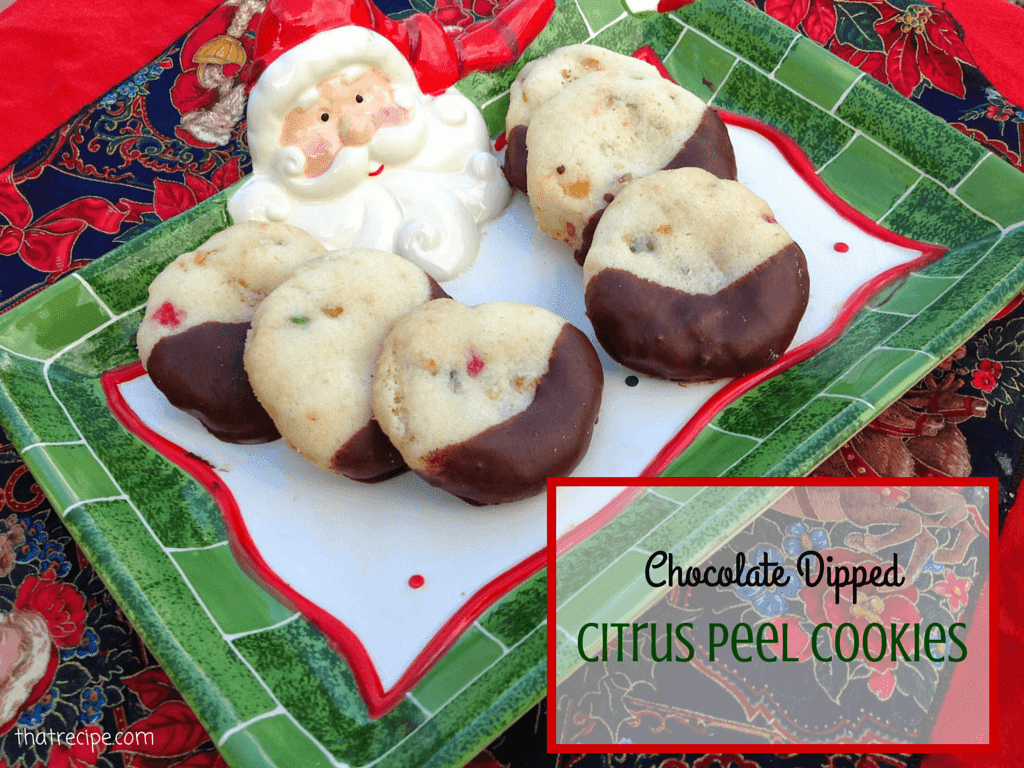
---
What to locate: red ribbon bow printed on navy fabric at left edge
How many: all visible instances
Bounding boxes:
[0,167,134,273]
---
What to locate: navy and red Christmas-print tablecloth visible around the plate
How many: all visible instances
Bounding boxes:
[0,0,1024,768]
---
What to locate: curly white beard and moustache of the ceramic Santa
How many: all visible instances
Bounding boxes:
[228,92,510,281]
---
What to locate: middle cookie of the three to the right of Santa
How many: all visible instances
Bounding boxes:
[526,71,736,264]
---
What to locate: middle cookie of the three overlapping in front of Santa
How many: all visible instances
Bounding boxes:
[245,249,447,482]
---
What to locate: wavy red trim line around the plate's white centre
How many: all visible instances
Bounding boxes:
[101,112,946,718]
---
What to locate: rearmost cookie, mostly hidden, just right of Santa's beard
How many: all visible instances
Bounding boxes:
[503,43,662,193]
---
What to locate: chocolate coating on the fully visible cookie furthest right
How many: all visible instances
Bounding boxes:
[585,243,810,382]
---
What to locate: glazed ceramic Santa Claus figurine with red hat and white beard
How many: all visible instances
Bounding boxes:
[228,0,550,281]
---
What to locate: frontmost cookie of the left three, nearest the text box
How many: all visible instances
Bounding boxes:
[373,299,604,505]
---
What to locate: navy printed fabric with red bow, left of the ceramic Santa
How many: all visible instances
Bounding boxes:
[0,0,256,310]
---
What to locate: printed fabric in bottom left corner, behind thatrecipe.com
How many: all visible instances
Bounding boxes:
[0,481,224,768]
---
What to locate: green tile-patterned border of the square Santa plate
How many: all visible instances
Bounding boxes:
[0,0,1024,768]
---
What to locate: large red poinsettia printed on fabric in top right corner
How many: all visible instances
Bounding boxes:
[871,2,974,98]
